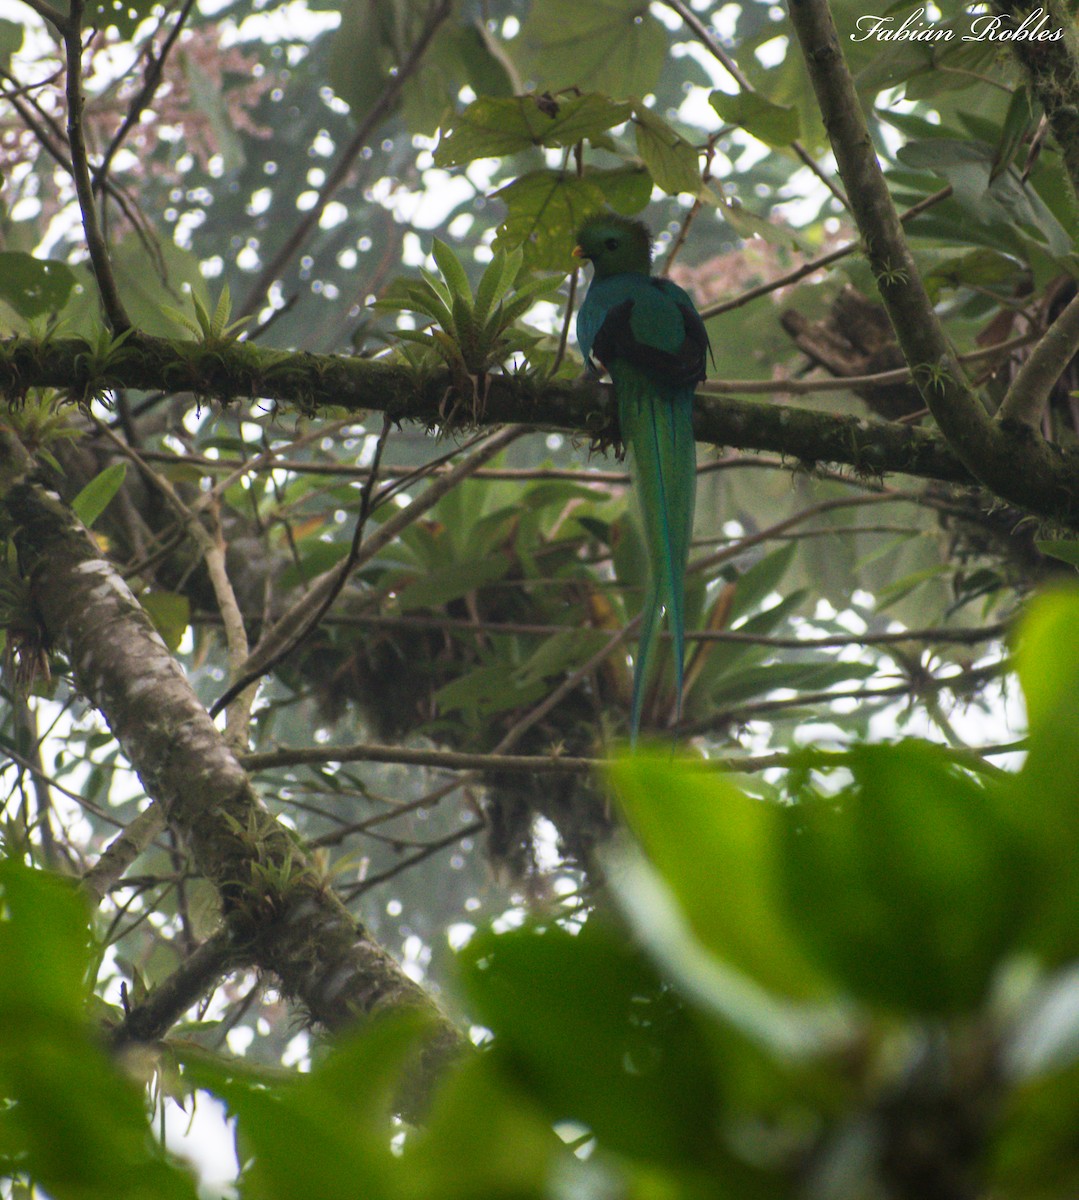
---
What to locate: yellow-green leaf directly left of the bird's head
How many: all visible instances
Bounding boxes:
[494,170,604,271]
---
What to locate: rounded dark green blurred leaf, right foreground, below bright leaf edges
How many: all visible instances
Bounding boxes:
[781,742,1031,1015]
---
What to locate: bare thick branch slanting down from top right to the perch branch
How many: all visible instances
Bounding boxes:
[790,0,1079,524]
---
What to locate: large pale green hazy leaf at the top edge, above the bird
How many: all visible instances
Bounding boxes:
[515,0,667,96]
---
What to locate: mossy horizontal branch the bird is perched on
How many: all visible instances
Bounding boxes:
[0,335,979,494]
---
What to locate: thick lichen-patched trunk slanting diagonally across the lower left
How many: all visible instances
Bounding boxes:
[0,431,458,1100]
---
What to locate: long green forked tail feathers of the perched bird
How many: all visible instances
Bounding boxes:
[611,362,696,742]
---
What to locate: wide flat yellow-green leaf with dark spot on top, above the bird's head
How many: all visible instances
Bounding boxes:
[434,92,631,167]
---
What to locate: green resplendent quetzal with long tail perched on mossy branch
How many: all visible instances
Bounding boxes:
[574,214,709,740]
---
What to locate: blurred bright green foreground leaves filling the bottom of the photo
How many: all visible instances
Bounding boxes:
[10,592,1079,1200]
